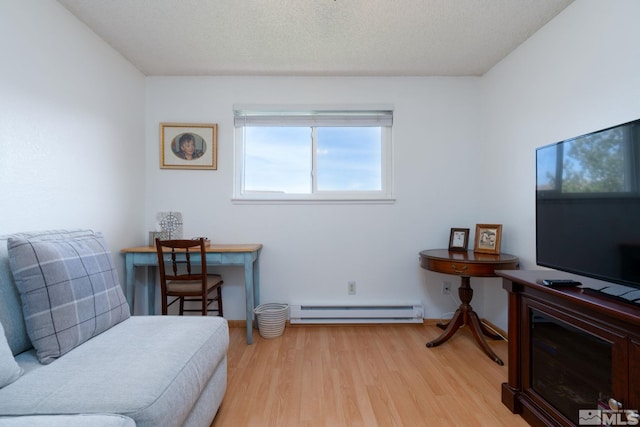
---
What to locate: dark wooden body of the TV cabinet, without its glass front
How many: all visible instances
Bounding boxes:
[496,270,640,426]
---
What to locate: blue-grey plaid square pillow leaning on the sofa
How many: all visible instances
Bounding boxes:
[7,233,129,364]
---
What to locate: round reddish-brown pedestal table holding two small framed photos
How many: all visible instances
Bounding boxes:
[420,249,518,365]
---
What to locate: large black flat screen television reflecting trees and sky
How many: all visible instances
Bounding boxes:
[536,119,640,289]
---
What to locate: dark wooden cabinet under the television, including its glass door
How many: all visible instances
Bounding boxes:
[497,270,640,426]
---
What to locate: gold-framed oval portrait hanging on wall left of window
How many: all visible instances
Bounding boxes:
[160,123,218,170]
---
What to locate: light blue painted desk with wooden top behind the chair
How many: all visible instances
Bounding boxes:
[121,244,262,344]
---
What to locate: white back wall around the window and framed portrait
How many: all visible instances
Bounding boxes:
[146,77,482,319]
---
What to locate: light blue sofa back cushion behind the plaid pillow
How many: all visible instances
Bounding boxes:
[0,229,94,355]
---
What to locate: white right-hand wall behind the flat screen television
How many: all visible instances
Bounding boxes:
[479,0,640,323]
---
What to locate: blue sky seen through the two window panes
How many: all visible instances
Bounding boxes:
[244,126,382,194]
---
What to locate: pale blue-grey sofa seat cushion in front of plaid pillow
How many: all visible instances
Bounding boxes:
[0,316,229,427]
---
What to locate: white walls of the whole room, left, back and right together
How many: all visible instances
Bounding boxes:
[0,0,640,328]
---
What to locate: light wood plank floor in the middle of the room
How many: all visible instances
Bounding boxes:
[212,325,528,427]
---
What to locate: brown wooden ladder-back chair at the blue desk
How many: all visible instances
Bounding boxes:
[156,238,223,317]
